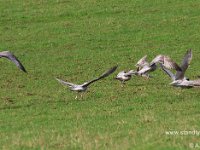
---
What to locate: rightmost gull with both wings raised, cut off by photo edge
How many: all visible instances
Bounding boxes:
[161,49,200,88]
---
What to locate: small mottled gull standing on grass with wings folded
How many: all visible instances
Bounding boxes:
[115,70,136,87]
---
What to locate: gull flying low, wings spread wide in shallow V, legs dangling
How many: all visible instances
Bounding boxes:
[56,66,118,99]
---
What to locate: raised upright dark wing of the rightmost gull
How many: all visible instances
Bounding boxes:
[176,49,192,80]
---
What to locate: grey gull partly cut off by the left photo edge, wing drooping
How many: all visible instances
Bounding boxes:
[0,51,26,72]
